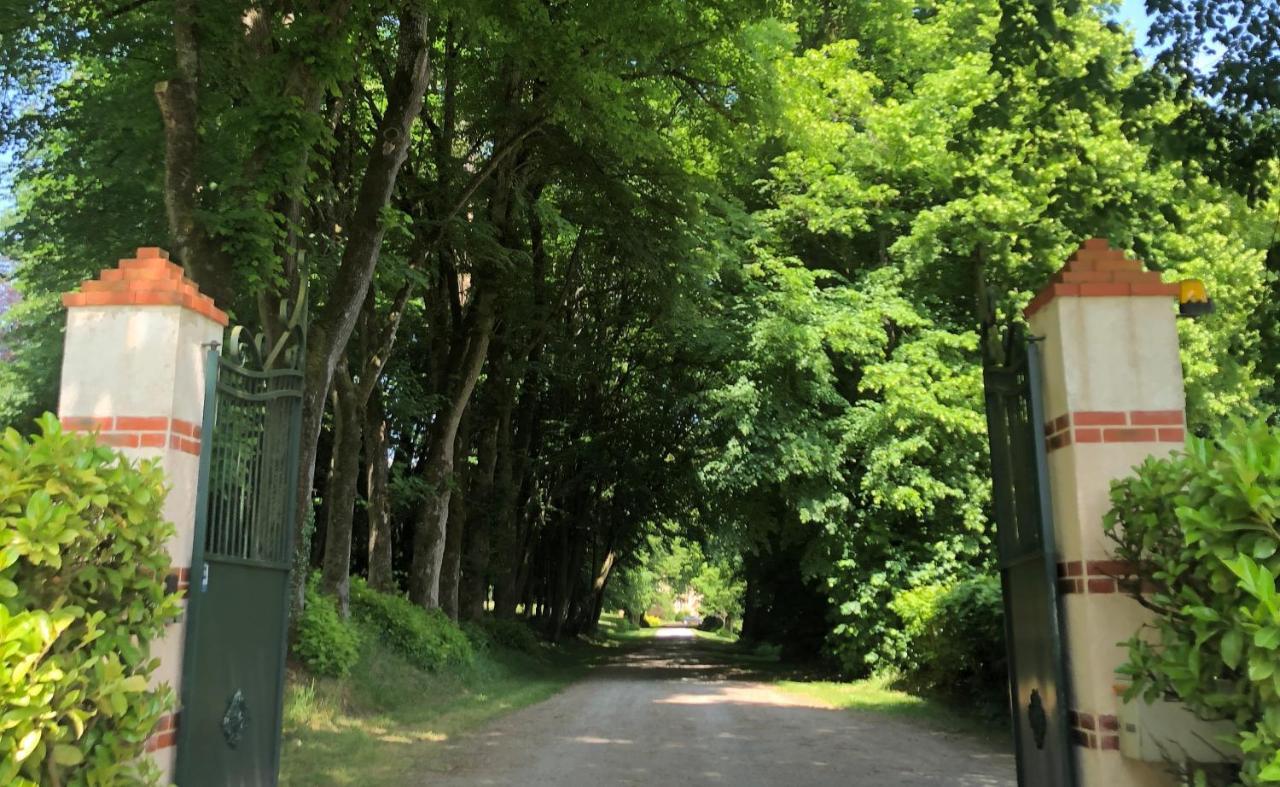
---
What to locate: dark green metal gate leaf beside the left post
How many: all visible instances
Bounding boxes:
[177,331,302,787]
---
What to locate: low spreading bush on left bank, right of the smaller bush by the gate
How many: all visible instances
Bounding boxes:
[351,577,475,669]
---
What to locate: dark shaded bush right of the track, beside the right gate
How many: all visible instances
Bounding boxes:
[892,576,1007,704]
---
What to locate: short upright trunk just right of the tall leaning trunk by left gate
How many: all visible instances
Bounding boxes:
[320,362,362,617]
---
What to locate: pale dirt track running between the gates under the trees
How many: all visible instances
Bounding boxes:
[421,630,1015,787]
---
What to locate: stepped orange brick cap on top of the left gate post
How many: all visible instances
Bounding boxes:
[63,246,230,328]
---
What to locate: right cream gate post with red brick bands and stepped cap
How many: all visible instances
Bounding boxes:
[1024,238,1185,787]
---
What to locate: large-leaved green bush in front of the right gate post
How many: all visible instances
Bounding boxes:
[1105,425,1280,784]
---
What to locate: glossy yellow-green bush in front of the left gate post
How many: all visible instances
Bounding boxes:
[0,415,179,784]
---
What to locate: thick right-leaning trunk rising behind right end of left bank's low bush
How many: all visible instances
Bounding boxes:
[408,289,494,609]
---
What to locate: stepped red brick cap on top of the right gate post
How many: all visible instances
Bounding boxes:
[1023,238,1178,317]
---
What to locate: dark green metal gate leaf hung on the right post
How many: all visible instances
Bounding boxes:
[983,325,1075,787]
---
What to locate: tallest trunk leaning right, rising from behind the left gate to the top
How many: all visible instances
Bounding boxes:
[293,9,430,612]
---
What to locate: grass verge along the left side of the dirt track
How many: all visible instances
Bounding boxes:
[280,627,599,786]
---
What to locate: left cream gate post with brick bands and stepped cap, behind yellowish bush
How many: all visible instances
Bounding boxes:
[58,247,228,783]
